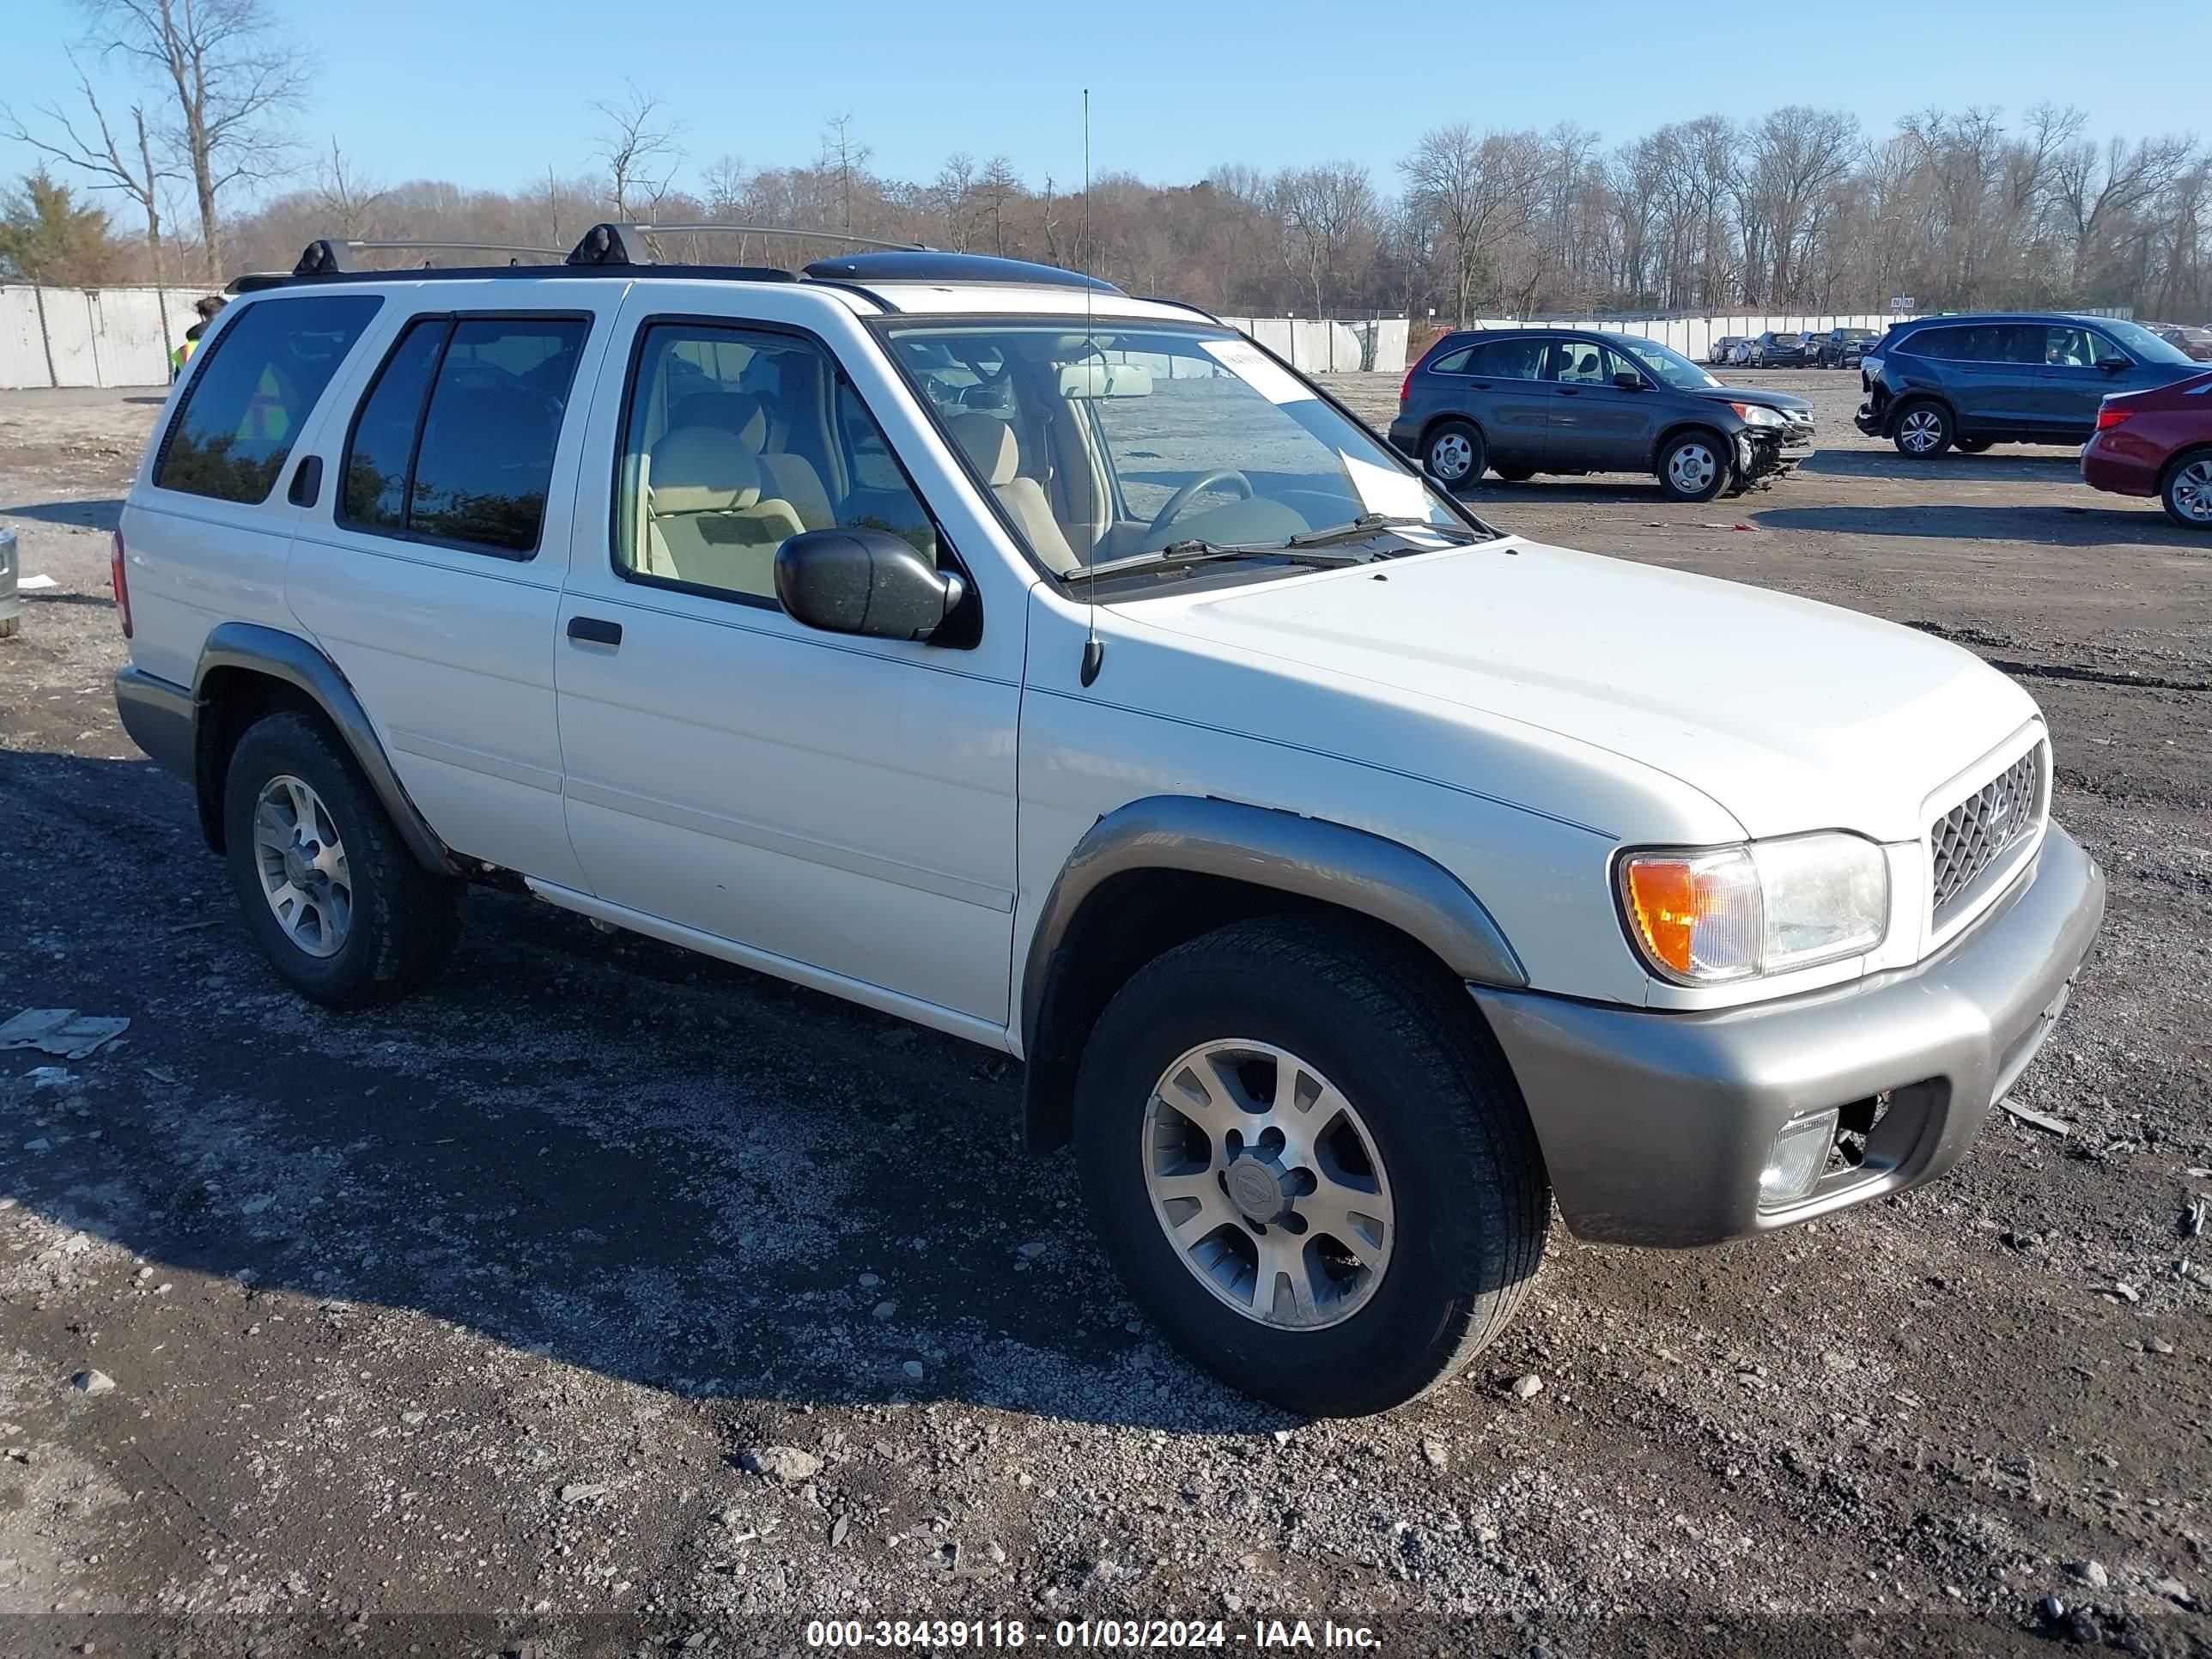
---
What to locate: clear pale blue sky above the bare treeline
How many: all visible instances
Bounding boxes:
[0,0,2212,204]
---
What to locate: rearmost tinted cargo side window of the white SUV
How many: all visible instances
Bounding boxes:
[153,295,383,502]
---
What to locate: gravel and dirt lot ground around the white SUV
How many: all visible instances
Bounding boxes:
[0,372,2212,1659]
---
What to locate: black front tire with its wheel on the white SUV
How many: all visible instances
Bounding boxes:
[1075,918,1551,1416]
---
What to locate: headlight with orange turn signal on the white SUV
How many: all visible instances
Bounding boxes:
[1620,832,1889,984]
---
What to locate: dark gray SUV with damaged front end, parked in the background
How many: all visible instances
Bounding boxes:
[1389,327,1812,502]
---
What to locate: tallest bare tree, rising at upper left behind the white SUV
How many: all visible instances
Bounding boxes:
[80,0,314,281]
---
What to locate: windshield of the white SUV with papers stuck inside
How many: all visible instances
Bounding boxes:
[884,321,1468,575]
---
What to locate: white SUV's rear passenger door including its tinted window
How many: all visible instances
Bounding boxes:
[288,281,622,883]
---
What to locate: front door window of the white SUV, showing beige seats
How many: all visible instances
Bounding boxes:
[615,323,942,604]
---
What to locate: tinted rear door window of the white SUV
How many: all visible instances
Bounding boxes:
[338,316,591,557]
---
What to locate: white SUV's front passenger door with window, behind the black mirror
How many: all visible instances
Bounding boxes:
[553,283,1022,1036]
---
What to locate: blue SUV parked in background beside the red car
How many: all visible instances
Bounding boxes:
[1854,312,2203,458]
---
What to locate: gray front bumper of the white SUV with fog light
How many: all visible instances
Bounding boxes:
[1468,825,2104,1248]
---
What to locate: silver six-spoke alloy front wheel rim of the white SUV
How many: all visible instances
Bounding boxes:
[1139,1037,1398,1329]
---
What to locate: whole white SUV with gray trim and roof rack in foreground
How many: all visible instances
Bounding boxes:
[115,226,2104,1413]
